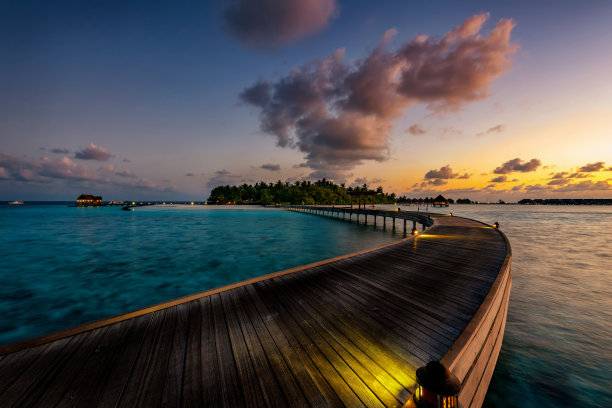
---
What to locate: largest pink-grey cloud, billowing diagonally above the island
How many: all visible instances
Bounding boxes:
[240,13,518,175]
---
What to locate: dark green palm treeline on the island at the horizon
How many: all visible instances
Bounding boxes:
[208,179,472,205]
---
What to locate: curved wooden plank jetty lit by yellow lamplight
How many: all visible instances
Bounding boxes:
[0,207,511,407]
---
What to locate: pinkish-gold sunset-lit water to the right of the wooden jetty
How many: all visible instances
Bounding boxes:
[440,205,612,408]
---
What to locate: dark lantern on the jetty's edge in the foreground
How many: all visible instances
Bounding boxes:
[404,361,461,408]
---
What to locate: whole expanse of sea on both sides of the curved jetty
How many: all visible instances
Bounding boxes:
[0,202,612,408]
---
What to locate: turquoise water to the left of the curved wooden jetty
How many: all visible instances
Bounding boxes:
[0,203,398,344]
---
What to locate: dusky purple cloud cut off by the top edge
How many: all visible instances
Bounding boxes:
[223,0,337,48]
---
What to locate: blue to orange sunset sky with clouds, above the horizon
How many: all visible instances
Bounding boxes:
[0,0,612,201]
